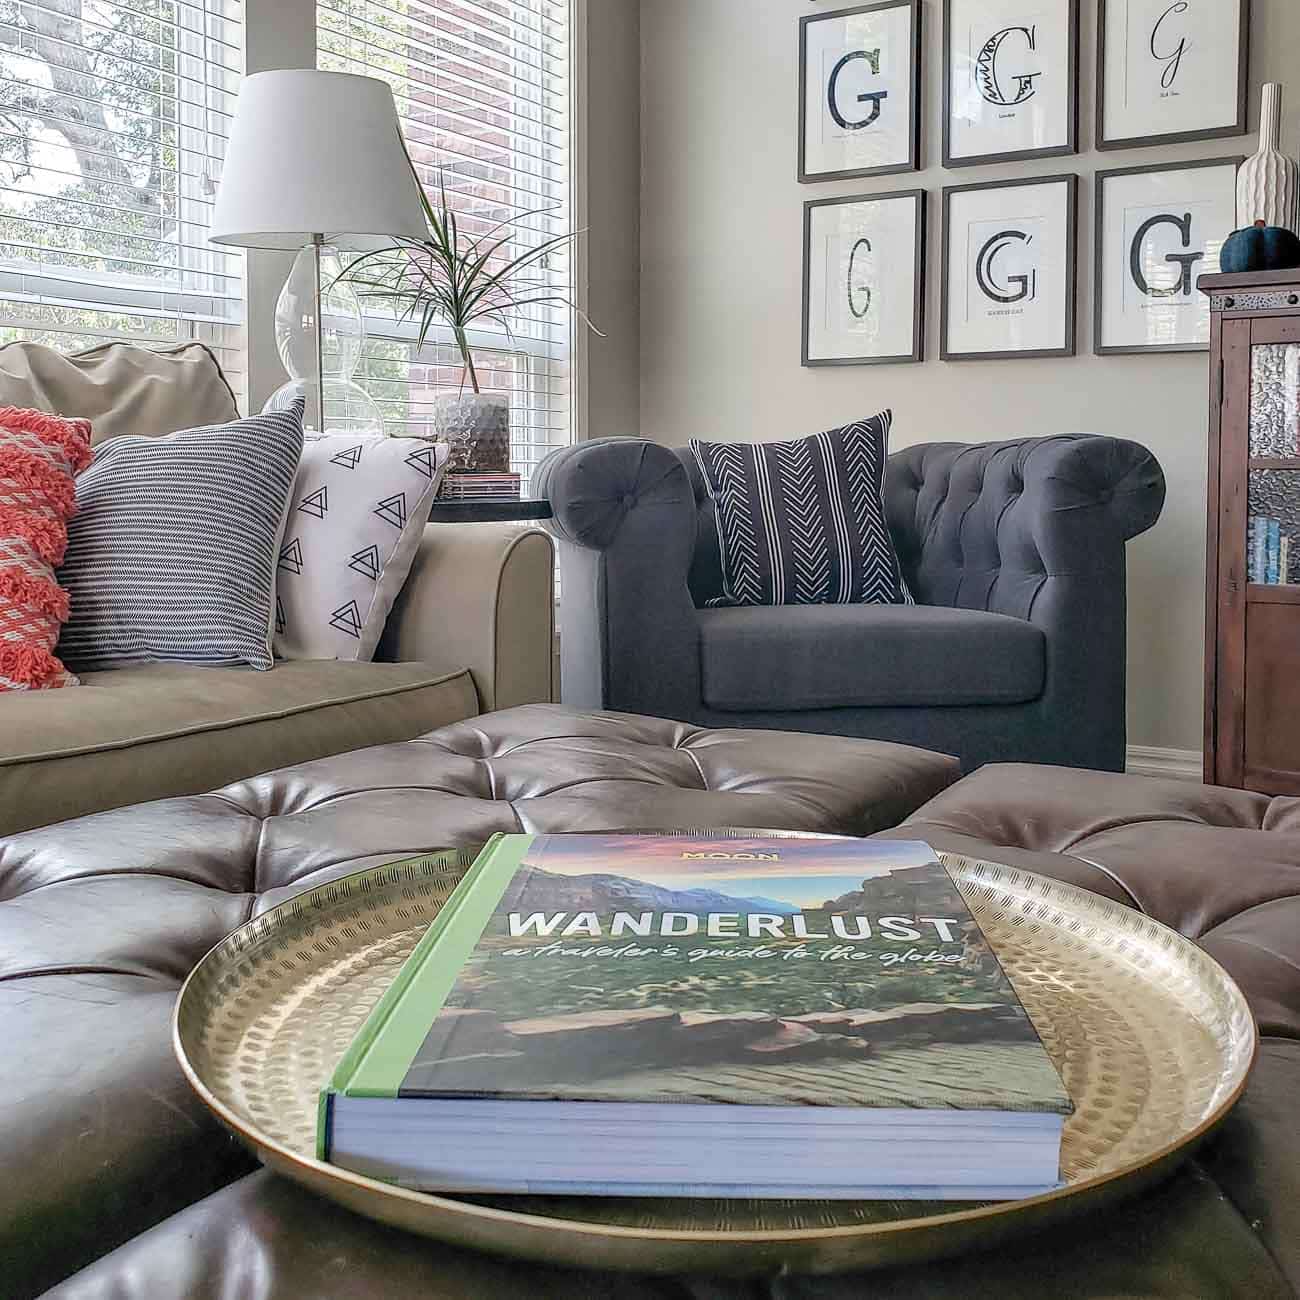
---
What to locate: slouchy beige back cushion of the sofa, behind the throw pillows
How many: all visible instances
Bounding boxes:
[0,339,239,443]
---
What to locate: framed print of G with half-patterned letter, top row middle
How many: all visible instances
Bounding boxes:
[944,0,1079,166]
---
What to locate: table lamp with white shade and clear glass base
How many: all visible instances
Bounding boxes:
[208,69,428,433]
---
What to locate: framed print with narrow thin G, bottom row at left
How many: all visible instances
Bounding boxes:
[803,190,926,365]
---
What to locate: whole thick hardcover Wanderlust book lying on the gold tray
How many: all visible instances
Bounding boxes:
[317,835,1073,1200]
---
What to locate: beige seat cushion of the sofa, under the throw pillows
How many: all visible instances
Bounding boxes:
[0,659,478,835]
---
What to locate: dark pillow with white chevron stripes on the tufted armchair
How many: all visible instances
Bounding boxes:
[690,411,911,605]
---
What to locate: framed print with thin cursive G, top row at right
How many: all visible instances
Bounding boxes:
[1097,0,1249,150]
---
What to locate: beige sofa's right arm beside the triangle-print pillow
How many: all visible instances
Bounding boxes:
[376,524,555,712]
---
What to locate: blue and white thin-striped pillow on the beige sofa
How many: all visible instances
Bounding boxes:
[59,402,303,672]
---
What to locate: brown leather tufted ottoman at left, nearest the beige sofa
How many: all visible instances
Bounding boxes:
[0,705,958,1300]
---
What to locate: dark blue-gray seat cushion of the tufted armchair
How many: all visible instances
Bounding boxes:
[699,605,1047,712]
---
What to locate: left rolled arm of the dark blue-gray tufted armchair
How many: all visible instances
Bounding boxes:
[533,438,699,718]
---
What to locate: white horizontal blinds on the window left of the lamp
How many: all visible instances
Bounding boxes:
[0,0,244,397]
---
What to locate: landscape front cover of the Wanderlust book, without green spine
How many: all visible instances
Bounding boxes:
[398,835,1070,1114]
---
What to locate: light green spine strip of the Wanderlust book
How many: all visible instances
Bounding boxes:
[316,835,533,1160]
